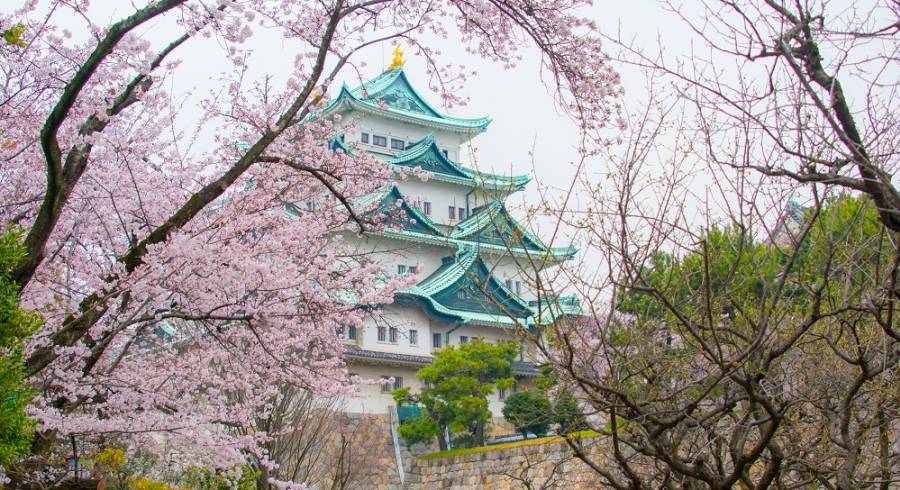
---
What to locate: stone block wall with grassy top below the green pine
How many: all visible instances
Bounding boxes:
[405,439,600,490]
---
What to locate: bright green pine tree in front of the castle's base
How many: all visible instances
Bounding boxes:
[393,339,518,446]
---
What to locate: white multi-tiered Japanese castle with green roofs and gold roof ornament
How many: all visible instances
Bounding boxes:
[321,49,577,419]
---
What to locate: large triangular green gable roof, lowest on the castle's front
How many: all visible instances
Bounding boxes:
[398,247,533,326]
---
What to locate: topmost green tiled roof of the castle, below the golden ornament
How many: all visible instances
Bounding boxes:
[321,68,491,135]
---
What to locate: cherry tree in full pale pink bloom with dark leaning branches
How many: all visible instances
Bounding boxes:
[0,0,620,483]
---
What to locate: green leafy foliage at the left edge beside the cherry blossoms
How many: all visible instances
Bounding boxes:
[0,230,40,466]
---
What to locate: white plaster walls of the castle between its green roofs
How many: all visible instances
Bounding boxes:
[330,77,560,417]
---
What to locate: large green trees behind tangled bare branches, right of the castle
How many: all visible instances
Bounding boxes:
[588,194,900,487]
